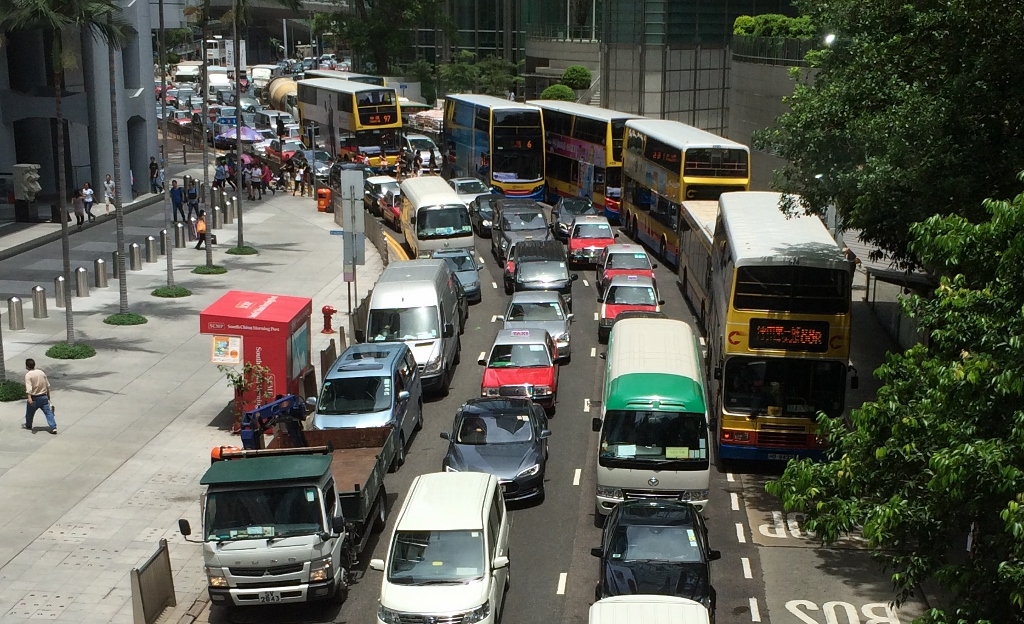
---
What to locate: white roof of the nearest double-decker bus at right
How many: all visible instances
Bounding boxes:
[718,191,852,271]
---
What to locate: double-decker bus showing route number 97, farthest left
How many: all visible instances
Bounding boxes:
[298,78,401,170]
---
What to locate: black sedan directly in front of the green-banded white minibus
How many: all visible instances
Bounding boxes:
[591,499,722,616]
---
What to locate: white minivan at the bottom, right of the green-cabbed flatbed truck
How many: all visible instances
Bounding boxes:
[370,472,509,624]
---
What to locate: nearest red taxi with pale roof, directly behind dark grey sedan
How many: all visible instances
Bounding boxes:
[480,329,558,412]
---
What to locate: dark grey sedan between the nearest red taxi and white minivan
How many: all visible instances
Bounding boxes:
[441,397,551,501]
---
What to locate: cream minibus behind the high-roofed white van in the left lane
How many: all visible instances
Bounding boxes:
[401,175,476,258]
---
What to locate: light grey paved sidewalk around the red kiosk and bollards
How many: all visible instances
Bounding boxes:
[0,173,382,623]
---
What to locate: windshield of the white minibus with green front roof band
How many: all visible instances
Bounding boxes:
[600,410,708,461]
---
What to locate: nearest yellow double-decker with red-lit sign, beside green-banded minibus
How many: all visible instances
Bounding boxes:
[708,193,857,460]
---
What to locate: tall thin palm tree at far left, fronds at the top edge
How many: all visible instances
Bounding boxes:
[0,0,133,345]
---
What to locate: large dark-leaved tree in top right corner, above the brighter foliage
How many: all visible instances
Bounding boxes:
[755,0,1024,262]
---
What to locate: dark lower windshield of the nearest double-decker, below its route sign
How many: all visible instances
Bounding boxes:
[723,357,846,420]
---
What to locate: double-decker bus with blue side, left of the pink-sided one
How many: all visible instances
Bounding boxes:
[441,94,544,201]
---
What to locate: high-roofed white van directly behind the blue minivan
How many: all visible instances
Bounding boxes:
[355,259,469,393]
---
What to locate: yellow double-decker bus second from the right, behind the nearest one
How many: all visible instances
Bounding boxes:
[622,119,751,265]
